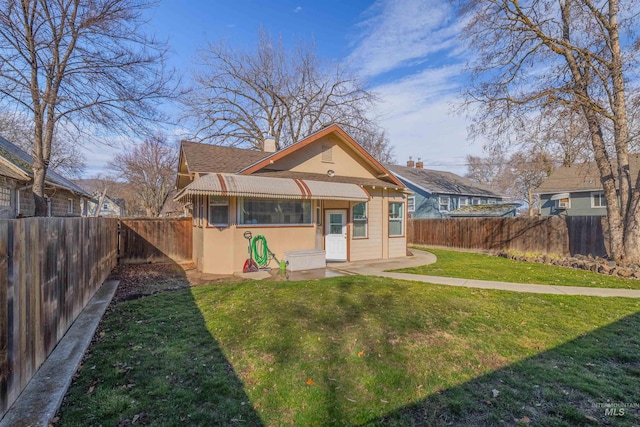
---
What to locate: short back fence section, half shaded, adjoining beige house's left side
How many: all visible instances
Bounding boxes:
[118,218,193,263]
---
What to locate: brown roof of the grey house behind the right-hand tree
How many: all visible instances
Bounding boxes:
[536,154,640,194]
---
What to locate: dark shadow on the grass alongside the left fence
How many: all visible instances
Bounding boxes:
[56,263,262,426]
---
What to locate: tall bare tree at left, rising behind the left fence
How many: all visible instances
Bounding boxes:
[0,0,171,216]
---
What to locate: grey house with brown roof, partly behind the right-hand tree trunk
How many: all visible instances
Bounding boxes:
[536,154,640,216]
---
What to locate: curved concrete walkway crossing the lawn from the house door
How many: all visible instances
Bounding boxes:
[327,250,640,298]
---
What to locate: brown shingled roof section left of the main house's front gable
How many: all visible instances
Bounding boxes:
[181,141,271,173]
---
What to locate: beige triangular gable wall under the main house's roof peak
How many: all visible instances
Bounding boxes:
[270,135,376,178]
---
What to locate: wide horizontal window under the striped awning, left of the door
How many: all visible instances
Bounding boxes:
[238,199,312,225]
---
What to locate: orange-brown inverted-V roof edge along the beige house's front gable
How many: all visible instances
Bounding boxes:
[240,124,404,187]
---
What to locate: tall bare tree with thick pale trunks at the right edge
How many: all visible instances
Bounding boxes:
[464,0,640,261]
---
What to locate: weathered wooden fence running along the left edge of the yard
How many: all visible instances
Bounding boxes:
[0,218,118,417]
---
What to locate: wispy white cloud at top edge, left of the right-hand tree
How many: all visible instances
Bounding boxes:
[349,0,461,77]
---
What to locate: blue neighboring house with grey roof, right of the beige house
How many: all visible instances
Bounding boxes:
[385,160,508,218]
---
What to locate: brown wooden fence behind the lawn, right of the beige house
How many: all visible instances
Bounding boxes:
[407,216,607,257]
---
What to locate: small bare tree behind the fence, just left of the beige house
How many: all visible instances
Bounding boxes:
[109,135,178,217]
